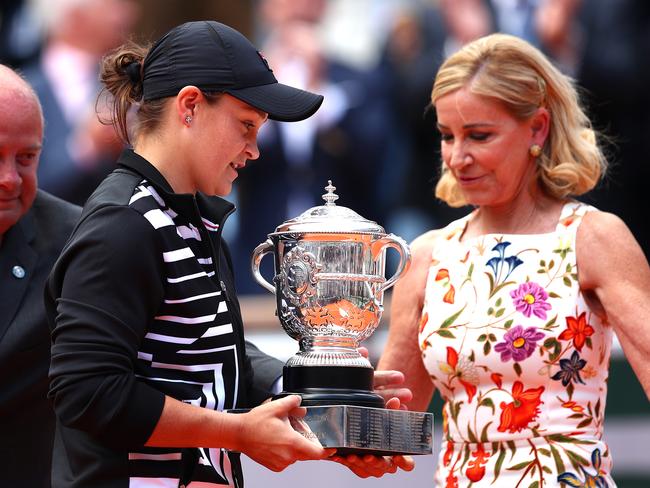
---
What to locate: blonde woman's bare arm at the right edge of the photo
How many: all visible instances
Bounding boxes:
[576,212,650,399]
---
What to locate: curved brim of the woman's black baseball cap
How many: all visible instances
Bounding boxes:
[225,83,323,122]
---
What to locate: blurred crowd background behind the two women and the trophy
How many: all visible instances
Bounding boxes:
[0,0,650,488]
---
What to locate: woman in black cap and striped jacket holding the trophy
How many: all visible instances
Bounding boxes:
[46,21,413,487]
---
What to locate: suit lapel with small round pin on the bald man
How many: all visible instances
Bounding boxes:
[0,212,38,341]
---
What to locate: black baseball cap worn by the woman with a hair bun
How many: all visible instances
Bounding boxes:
[142,20,323,122]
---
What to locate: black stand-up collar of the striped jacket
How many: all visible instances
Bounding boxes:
[117,149,235,226]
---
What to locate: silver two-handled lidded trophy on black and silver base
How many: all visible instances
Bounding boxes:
[251,181,433,454]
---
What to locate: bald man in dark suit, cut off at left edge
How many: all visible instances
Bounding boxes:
[0,65,81,488]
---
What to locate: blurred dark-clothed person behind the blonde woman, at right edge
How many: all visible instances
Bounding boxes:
[576,0,650,257]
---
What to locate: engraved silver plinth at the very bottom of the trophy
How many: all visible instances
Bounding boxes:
[291,405,433,456]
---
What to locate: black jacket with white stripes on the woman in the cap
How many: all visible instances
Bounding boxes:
[46,151,281,487]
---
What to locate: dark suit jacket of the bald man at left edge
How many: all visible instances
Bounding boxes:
[0,191,81,488]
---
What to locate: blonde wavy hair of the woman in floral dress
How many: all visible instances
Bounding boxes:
[431,34,607,207]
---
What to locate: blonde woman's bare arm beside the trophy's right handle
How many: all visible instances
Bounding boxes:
[377,231,436,411]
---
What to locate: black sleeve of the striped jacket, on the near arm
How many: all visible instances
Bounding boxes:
[46,206,164,447]
